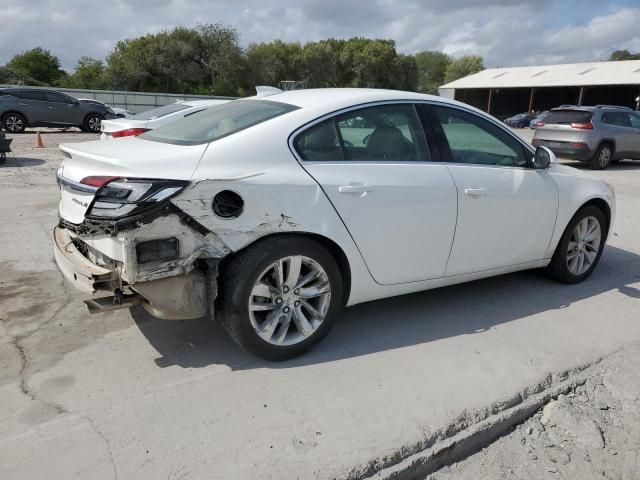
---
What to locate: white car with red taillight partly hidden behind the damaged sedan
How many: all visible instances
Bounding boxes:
[100,99,229,140]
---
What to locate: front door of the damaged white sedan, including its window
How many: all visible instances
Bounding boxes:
[429,105,558,276]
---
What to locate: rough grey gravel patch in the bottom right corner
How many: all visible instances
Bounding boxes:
[427,344,640,480]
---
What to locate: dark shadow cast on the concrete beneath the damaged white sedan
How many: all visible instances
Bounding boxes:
[131,247,640,370]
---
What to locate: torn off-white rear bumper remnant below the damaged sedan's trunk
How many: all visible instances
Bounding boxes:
[53,227,118,294]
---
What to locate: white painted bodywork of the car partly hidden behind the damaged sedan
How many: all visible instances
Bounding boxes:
[100,99,230,140]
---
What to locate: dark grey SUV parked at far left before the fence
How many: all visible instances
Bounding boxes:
[0,88,116,133]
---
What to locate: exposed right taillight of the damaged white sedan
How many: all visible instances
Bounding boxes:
[83,177,189,219]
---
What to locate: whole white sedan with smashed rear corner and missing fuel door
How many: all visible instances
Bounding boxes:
[54,89,615,360]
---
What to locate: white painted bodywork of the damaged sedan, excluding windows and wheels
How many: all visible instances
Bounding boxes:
[52,89,615,326]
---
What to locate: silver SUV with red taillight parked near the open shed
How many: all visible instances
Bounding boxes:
[531,105,640,170]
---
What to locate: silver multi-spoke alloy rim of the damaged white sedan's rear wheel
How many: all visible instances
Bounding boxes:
[249,255,331,346]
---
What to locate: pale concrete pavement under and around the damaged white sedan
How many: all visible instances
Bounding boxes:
[0,128,640,480]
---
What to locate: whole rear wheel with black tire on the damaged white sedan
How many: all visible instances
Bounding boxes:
[215,235,343,361]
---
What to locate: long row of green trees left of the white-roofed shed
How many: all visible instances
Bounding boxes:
[0,27,480,96]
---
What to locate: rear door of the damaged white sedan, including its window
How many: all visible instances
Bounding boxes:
[293,103,457,285]
